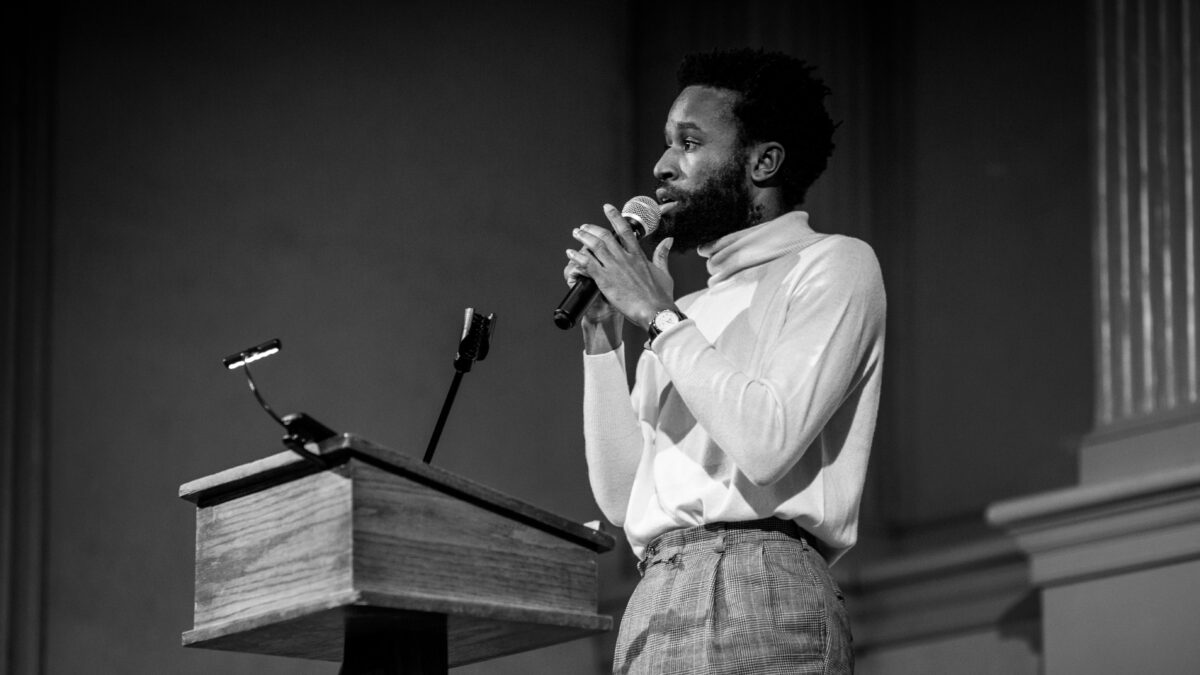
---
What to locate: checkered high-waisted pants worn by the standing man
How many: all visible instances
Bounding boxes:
[613,519,854,675]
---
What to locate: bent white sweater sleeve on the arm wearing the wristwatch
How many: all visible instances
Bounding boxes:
[653,238,886,485]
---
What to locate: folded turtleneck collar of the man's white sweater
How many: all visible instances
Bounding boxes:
[696,211,821,287]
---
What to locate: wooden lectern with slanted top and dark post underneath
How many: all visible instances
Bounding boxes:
[179,435,613,675]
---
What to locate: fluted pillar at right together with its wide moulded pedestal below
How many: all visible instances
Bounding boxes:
[988,6,1200,675]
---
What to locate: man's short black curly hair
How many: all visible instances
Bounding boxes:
[677,49,836,205]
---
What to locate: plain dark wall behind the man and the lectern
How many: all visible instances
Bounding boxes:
[4,0,1092,674]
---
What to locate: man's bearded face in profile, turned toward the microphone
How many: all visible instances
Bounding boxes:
[654,86,754,251]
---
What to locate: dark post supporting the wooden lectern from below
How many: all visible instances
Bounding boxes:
[338,608,450,675]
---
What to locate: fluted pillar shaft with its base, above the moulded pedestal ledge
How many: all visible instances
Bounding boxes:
[1080,0,1200,482]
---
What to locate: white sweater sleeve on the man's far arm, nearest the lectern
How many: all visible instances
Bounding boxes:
[583,345,643,527]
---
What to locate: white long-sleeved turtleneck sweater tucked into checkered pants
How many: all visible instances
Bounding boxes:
[583,211,886,562]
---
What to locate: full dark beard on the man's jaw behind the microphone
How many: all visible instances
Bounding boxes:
[655,153,757,252]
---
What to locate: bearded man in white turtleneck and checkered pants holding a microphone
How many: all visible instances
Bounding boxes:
[564,50,886,675]
